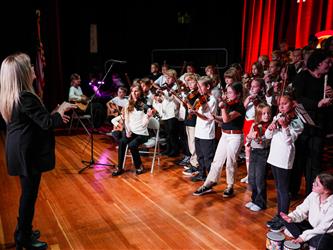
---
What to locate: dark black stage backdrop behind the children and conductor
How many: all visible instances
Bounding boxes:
[1,0,243,108]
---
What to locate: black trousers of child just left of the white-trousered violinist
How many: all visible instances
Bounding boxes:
[195,138,215,178]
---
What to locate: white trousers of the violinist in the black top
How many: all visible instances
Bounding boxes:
[204,132,243,186]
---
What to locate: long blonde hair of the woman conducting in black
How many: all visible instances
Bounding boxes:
[0,53,35,123]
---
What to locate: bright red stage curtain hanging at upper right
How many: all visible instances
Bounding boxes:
[242,0,333,71]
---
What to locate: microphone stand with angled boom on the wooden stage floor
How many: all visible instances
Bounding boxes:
[79,62,115,174]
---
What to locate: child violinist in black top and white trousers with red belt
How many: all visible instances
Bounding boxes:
[193,82,245,197]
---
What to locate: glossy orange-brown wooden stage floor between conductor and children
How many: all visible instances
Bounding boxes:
[0,131,326,250]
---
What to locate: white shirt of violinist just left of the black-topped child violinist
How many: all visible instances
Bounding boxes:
[194,96,217,140]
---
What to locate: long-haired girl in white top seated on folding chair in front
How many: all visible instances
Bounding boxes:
[112,83,153,176]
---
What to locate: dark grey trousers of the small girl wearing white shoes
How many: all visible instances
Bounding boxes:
[249,148,269,208]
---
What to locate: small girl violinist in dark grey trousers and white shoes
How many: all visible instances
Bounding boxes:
[245,103,271,212]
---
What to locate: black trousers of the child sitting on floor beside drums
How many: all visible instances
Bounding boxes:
[282,220,333,250]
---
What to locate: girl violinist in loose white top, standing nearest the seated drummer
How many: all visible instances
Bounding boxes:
[265,93,304,231]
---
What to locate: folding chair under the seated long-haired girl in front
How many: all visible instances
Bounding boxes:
[123,117,160,173]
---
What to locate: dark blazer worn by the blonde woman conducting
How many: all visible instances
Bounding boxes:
[6,91,62,176]
